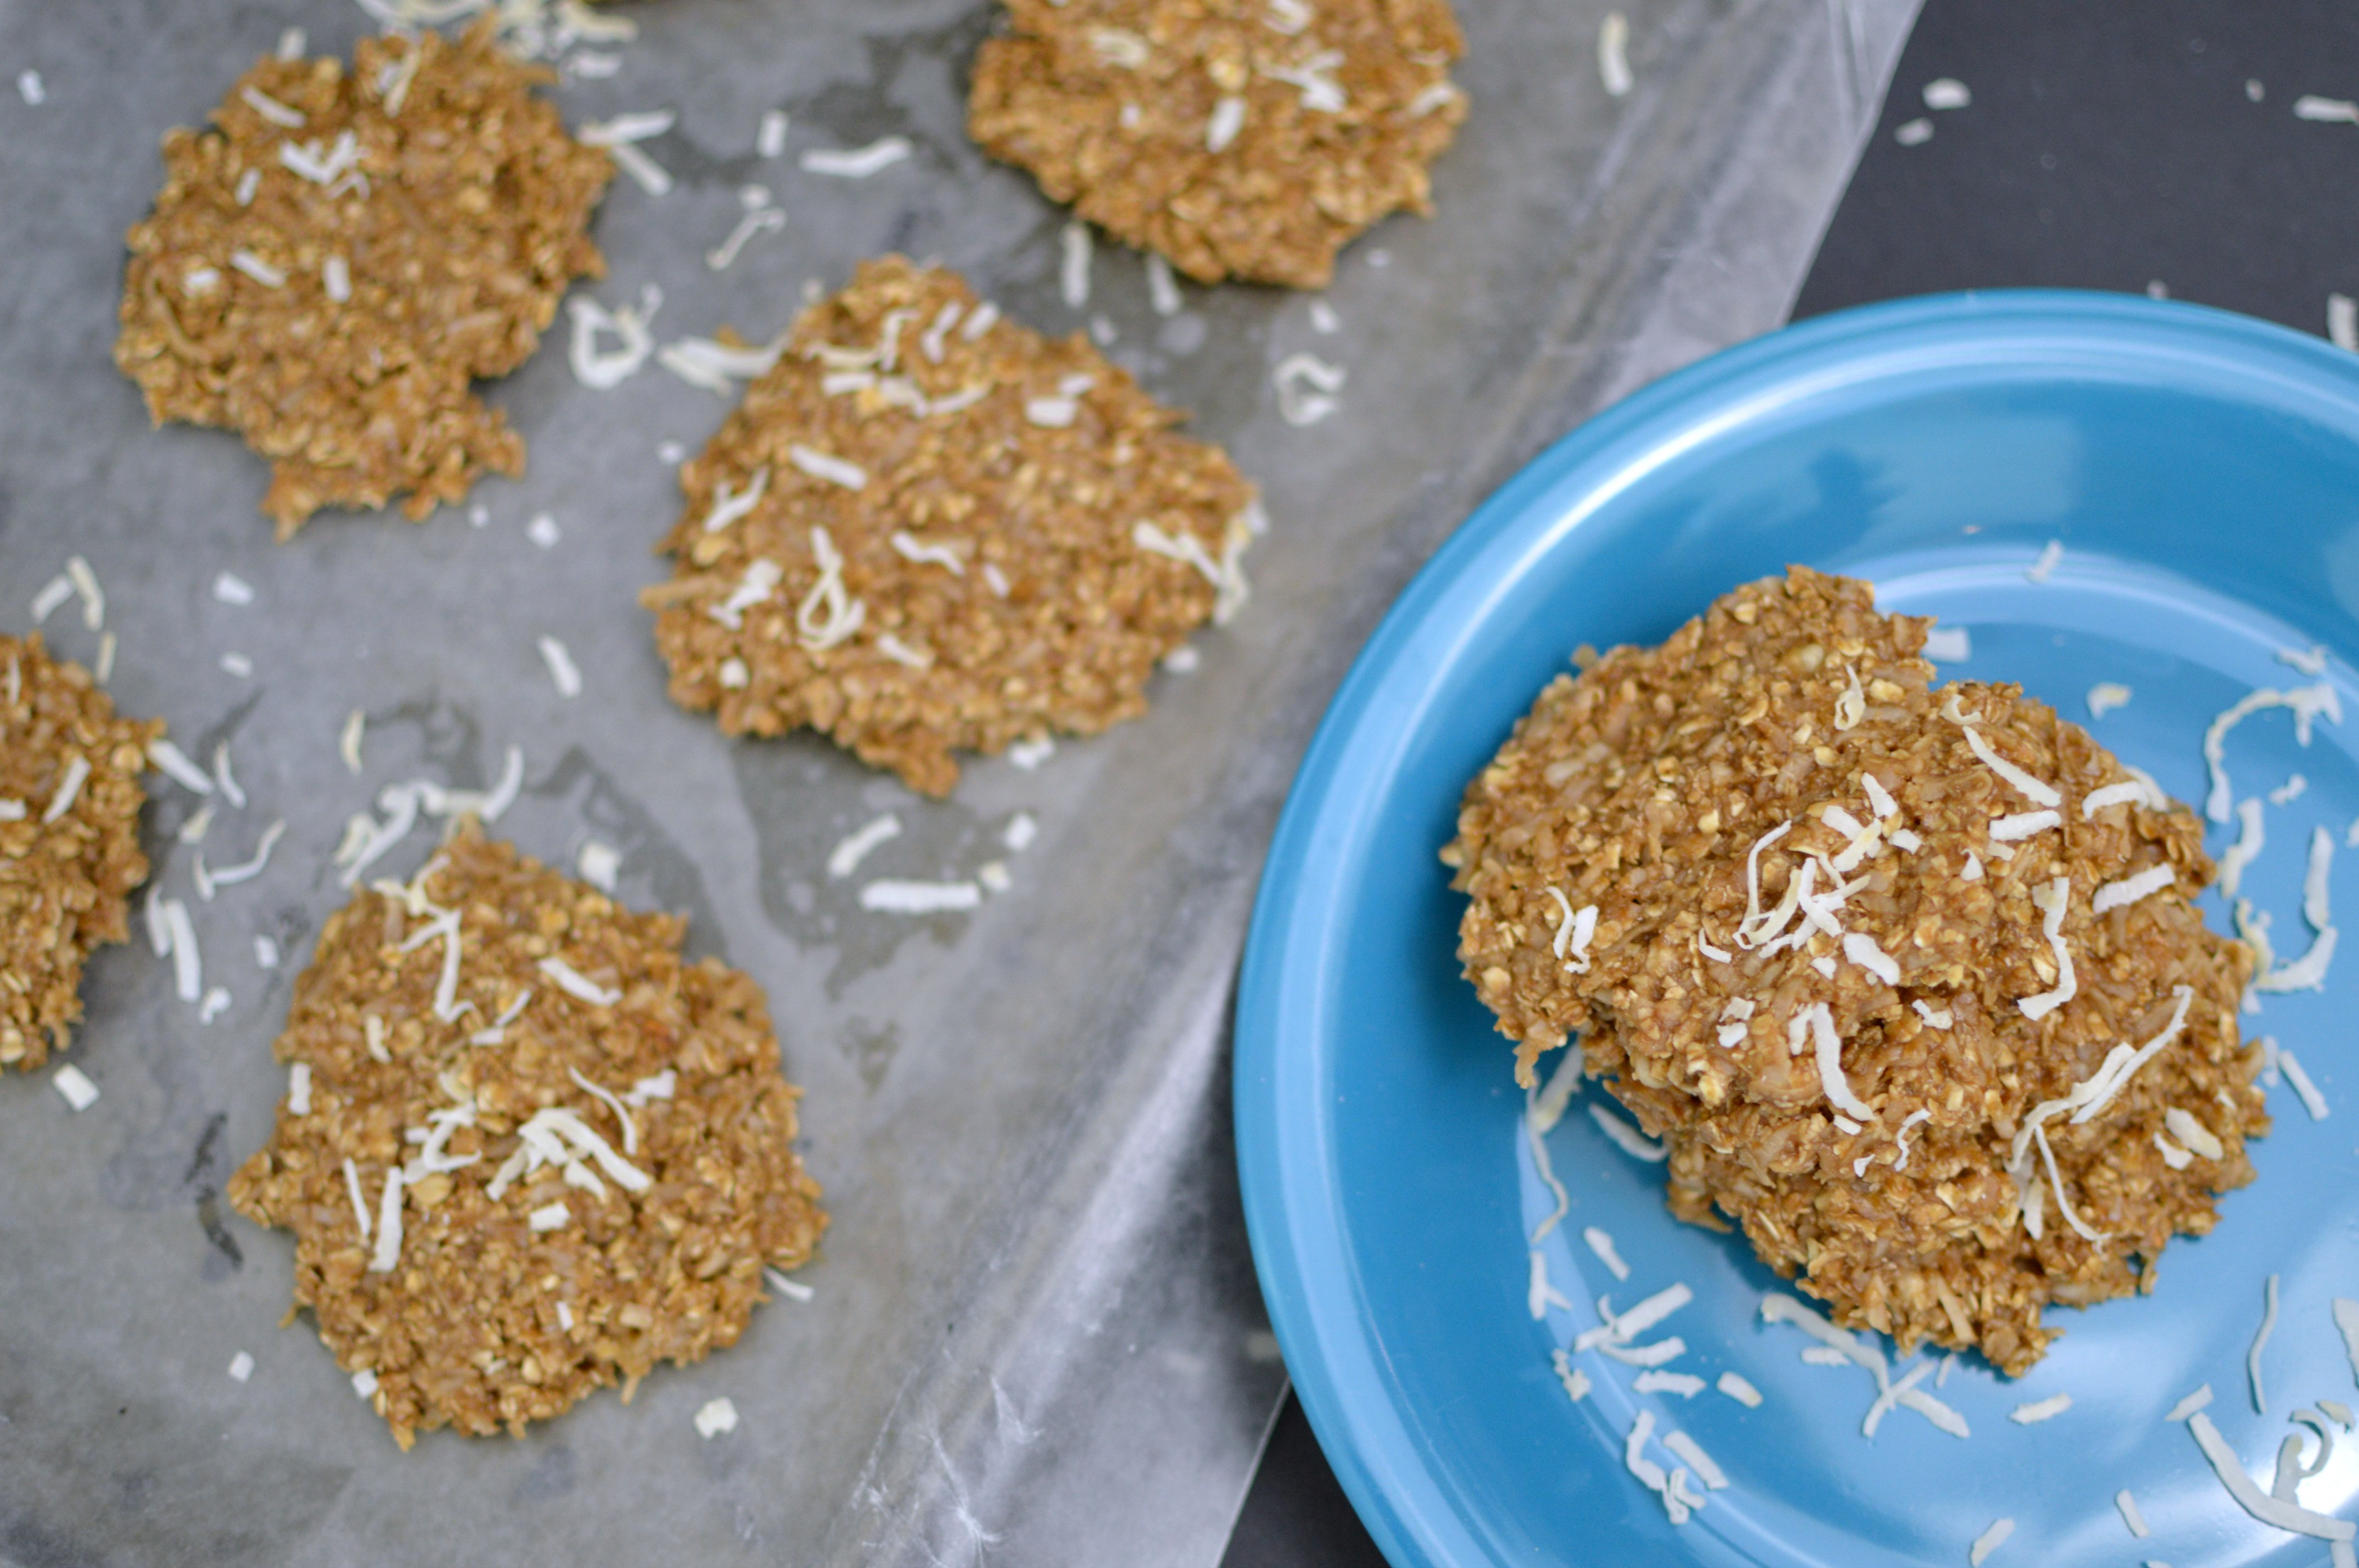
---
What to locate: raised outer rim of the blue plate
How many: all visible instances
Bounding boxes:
[1232,290,2359,1568]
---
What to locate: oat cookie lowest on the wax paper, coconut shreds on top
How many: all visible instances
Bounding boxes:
[229,826,828,1448]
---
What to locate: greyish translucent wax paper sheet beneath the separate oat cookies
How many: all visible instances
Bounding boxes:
[0,0,1913,1568]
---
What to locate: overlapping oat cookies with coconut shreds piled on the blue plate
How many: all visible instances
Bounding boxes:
[1444,569,2270,1375]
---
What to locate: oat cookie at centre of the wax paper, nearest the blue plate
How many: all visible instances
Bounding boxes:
[642,257,1257,794]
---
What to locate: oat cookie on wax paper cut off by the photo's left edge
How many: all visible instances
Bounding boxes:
[0,632,163,1073]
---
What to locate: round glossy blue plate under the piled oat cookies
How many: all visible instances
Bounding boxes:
[1236,295,2359,1568]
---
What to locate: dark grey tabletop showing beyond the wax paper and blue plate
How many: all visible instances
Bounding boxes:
[1222,0,2359,1568]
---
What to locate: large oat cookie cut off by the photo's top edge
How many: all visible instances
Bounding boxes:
[967,0,1467,287]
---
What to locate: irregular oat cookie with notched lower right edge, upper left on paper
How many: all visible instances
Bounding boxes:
[116,21,613,540]
